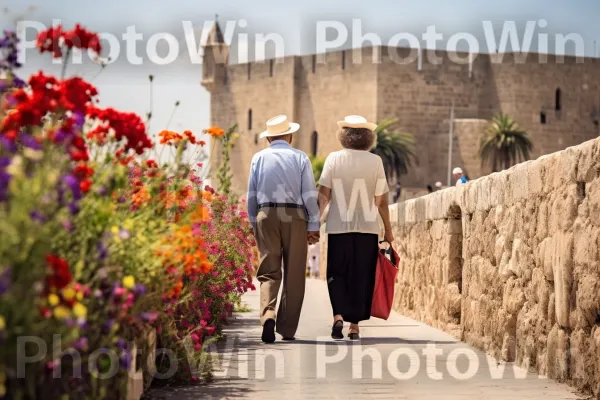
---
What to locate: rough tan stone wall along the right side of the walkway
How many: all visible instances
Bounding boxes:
[390,139,600,396]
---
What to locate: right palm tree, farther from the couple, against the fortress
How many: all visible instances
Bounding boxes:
[479,113,533,172]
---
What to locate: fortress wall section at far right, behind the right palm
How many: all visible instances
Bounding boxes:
[479,54,600,158]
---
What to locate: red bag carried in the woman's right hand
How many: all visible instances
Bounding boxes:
[371,245,400,320]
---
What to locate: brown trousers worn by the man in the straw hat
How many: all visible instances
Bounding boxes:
[256,208,308,338]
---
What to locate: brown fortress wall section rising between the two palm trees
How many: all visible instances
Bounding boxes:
[377,48,483,187]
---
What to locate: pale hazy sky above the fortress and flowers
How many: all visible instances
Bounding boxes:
[0,0,600,148]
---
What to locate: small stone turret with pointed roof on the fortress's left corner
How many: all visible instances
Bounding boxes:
[201,18,229,92]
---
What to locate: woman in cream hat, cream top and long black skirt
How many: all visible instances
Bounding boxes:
[319,116,394,340]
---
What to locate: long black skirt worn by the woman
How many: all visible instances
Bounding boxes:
[327,233,379,324]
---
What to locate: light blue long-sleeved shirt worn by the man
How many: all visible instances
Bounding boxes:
[248,140,319,232]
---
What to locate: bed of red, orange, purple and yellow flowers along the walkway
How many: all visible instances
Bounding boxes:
[0,25,255,399]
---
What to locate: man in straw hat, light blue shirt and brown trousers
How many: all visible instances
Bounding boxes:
[248,115,319,343]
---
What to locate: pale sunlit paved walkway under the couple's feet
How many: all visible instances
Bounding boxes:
[149,280,581,400]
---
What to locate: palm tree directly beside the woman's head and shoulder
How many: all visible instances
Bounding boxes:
[371,119,417,179]
